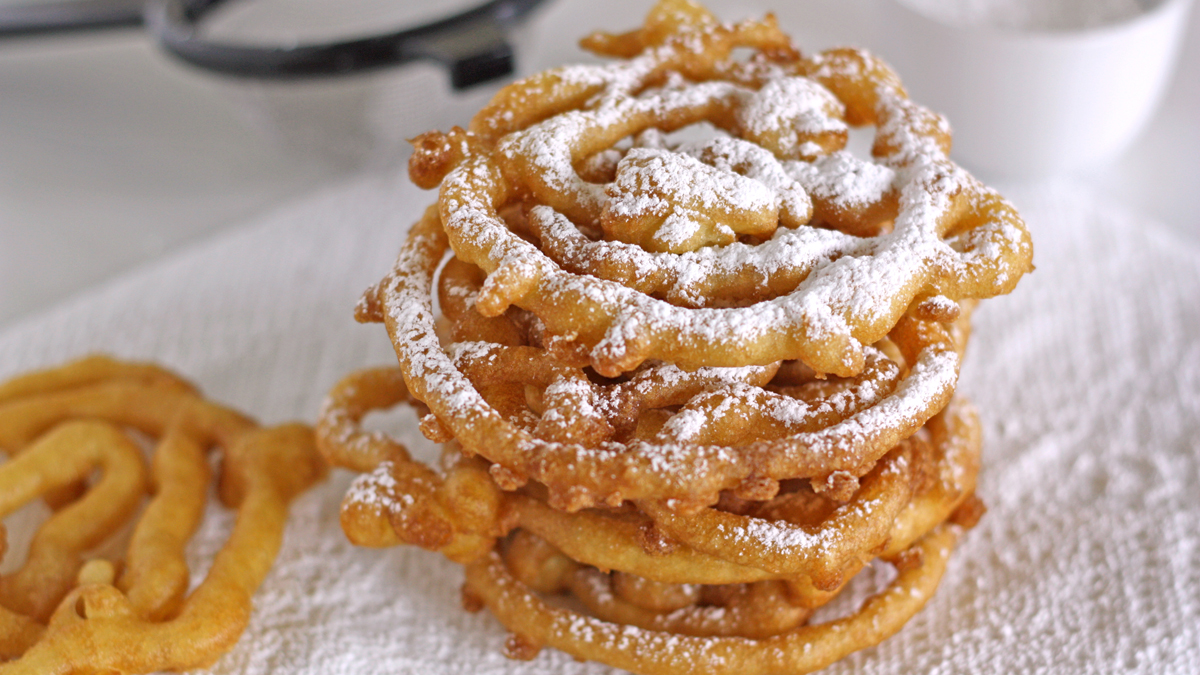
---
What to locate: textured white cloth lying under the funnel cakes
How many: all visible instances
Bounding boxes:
[0,169,1200,675]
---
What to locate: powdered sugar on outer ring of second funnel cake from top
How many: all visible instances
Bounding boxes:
[384,218,958,495]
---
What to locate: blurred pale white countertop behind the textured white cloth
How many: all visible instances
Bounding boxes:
[0,0,1200,328]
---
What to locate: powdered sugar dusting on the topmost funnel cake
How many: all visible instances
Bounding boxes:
[432,26,1028,374]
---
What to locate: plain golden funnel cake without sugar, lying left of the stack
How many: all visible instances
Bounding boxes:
[0,357,326,675]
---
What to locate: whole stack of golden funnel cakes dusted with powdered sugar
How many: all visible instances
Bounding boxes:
[319,0,1032,673]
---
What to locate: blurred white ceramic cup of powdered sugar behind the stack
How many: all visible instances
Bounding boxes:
[875,0,1192,178]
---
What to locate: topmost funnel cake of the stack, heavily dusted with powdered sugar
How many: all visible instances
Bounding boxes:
[413,3,1032,377]
